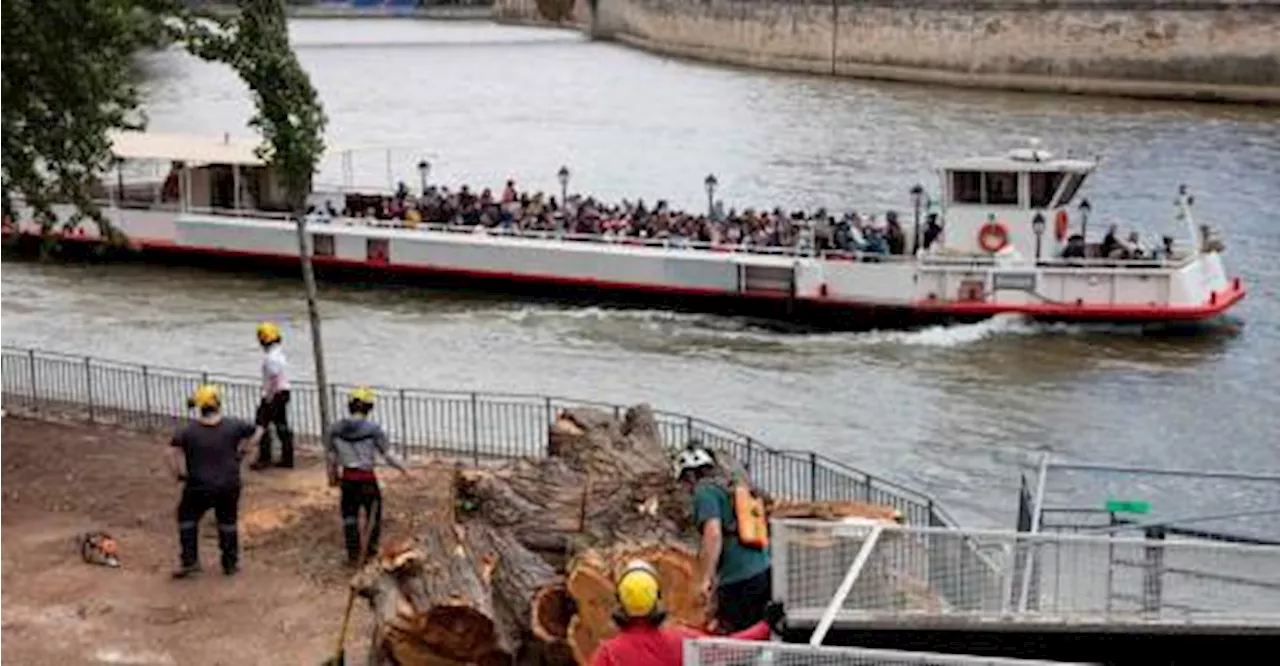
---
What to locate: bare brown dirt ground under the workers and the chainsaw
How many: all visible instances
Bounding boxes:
[0,416,451,666]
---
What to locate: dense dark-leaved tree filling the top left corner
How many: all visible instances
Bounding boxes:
[0,0,172,238]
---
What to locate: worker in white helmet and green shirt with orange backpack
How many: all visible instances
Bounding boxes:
[676,441,772,634]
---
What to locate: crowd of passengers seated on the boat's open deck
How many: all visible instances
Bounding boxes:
[314,181,1198,260]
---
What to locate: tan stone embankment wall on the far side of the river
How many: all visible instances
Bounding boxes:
[494,0,1280,104]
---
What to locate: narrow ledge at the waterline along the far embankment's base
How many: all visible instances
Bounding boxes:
[611,32,1280,106]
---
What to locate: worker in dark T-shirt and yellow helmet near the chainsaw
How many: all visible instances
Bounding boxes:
[169,384,264,578]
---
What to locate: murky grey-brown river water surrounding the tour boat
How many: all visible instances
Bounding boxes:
[0,20,1280,526]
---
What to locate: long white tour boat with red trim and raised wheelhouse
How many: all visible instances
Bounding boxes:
[0,132,1245,329]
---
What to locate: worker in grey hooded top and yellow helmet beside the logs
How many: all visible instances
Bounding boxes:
[325,387,408,566]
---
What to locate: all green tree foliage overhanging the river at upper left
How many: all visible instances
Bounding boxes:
[0,0,326,238]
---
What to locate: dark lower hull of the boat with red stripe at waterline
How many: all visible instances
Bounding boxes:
[0,229,1244,330]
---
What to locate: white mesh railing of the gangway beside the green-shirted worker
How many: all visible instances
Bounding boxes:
[772,520,1280,630]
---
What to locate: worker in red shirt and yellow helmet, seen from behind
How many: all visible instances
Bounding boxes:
[591,560,782,666]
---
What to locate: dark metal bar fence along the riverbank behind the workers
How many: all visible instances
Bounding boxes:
[0,346,955,525]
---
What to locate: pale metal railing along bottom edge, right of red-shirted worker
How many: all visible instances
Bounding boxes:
[684,638,1084,666]
